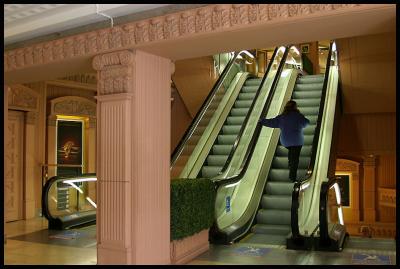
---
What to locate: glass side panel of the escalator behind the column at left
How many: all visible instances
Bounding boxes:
[47,176,97,218]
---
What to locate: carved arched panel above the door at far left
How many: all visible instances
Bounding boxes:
[7,84,39,111]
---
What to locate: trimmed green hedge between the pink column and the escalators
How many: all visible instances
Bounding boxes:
[171,178,216,241]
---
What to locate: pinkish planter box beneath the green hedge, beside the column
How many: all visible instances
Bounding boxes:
[170,229,210,264]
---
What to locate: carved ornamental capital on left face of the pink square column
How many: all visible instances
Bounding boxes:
[93,50,135,95]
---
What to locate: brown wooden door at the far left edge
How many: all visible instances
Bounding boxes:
[4,110,24,221]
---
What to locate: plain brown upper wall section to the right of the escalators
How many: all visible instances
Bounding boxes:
[337,32,396,114]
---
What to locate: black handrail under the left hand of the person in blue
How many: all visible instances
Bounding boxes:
[214,46,291,189]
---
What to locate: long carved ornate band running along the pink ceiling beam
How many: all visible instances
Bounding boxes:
[4,4,365,71]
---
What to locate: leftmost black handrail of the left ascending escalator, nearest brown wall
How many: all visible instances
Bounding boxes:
[170,52,239,169]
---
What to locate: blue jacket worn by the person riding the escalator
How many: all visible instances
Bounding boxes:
[260,111,310,147]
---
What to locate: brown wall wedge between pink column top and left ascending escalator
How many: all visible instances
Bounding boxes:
[172,56,217,118]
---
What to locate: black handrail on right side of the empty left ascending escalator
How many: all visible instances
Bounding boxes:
[218,47,279,175]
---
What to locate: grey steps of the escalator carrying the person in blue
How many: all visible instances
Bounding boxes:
[241,74,324,245]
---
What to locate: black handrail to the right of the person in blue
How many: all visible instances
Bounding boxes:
[291,41,333,238]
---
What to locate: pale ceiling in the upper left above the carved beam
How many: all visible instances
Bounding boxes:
[4,4,176,46]
